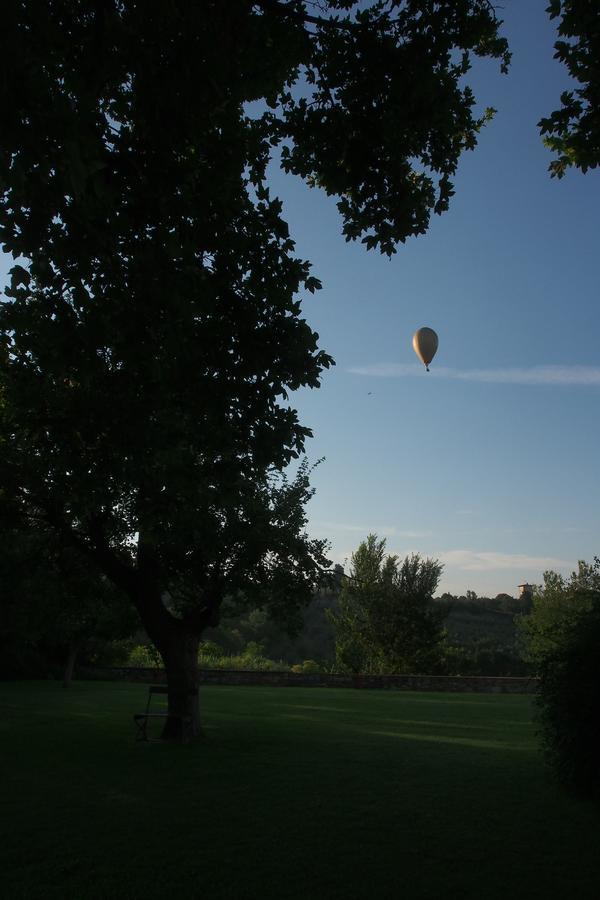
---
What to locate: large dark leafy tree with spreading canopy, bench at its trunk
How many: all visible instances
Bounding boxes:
[0,0,508,736]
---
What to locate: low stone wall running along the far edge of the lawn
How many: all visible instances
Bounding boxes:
[76,666,537,694]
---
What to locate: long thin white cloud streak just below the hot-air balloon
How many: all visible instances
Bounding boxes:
[347,362,600,387]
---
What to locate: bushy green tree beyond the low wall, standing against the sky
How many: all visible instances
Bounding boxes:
[330,534,446,673]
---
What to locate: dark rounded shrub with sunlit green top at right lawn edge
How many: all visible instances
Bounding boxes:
[519,557,600,801]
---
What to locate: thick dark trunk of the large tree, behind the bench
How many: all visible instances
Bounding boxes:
[159,627,202,740]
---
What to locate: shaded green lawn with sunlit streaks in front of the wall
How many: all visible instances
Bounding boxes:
[0,682,600,900]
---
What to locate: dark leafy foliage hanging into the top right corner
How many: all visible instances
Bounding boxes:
[538,0,600,178]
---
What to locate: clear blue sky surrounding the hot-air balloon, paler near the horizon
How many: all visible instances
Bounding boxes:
[0,0,600,595]
